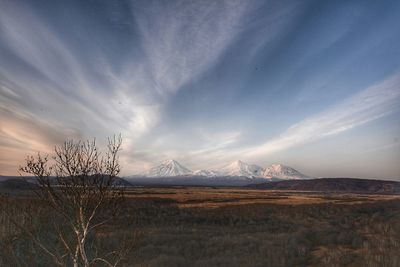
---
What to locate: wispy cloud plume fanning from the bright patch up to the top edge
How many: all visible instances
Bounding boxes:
[114,1,255,151]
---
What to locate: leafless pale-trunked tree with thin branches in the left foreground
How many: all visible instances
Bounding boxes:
[12,136,128,267]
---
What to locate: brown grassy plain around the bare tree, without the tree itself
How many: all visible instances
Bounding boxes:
[0,187,400,267]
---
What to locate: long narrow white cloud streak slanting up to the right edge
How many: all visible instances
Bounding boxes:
[243,74,400,158]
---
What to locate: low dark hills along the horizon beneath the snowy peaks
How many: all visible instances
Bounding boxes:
[0,175,400,195]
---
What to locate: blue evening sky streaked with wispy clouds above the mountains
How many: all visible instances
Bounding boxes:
[0,0,400,180]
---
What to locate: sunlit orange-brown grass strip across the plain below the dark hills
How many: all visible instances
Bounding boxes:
[126,187,400,209]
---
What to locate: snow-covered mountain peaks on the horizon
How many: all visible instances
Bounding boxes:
[131,159,312,180]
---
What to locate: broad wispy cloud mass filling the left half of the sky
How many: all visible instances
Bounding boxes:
[0,1,264,175]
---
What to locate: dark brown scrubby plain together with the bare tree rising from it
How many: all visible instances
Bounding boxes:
[0,138,400,267]
